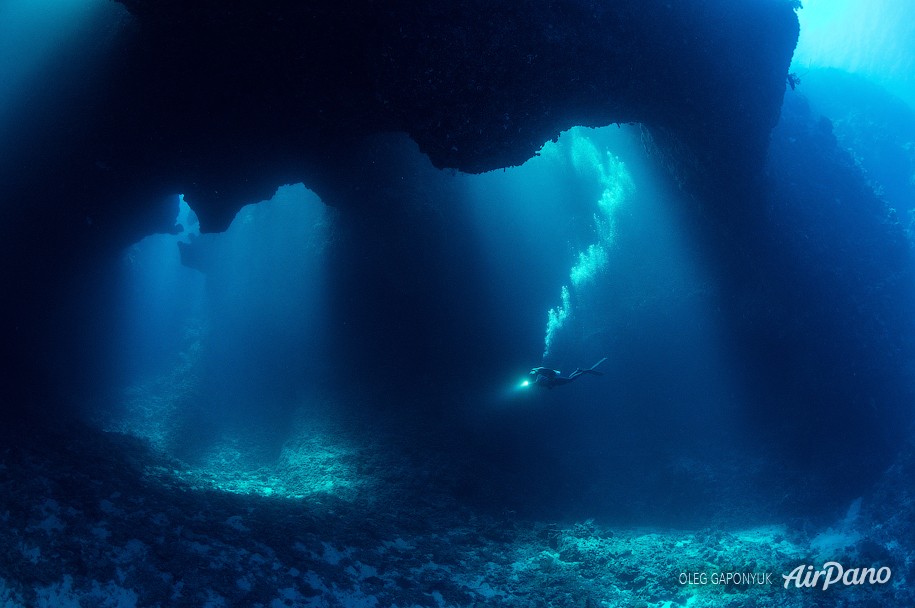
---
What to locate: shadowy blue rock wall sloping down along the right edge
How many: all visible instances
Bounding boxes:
[728,93,915,496]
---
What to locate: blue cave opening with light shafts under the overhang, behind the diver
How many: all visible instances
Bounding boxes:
[73,127,764,524]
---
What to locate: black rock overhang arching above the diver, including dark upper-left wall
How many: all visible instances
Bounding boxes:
[0,0,798,414]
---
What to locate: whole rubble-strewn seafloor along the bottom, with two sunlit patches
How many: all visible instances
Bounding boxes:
[0,402,912,608]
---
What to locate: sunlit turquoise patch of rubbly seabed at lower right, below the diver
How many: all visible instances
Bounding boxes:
[504,520,828,608]
